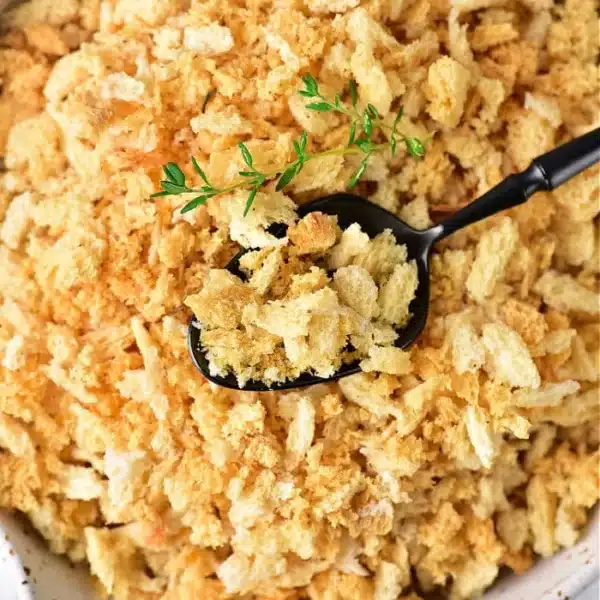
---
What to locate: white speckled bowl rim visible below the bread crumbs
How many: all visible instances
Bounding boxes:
[0,509,600,600]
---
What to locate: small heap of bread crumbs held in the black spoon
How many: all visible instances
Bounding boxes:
[190,212,418,387]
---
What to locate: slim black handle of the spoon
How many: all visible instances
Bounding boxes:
[430,128,600,241]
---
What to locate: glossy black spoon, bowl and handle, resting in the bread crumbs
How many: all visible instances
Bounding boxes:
[188,129,600,391]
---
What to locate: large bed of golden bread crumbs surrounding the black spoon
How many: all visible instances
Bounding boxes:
[0,0,600,600]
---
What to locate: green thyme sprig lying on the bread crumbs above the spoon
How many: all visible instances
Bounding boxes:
[152,75,428,216]
